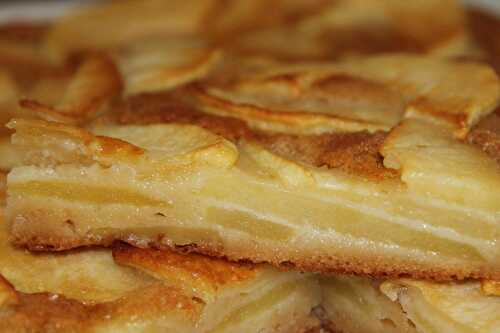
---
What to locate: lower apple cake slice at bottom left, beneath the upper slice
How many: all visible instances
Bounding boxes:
[0,208,320,333]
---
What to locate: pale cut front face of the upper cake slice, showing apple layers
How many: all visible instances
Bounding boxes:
[8,113,500,279]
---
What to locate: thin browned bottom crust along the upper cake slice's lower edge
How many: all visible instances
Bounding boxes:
[11,226,500,281]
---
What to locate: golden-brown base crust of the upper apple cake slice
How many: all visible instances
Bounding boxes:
[11,203,500,281]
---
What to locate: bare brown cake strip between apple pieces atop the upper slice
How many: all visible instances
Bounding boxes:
[104,93,397,180]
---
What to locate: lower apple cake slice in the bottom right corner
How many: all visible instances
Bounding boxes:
[321,276,500,333]
